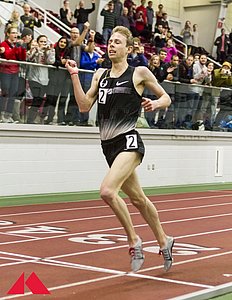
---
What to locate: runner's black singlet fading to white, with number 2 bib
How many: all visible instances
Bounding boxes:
[98,66,142,140]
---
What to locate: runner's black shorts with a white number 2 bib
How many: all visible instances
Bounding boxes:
[101,130,145,167]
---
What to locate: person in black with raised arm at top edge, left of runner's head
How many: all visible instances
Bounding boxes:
[74,0,95,33]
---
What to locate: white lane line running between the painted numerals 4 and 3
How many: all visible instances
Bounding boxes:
[0,213,232,245]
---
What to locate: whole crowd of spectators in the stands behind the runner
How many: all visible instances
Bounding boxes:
[0,0,232,130]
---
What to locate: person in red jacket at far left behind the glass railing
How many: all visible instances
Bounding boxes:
[0,27,26,123]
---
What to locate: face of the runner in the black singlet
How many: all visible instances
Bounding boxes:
[108,32,129,60]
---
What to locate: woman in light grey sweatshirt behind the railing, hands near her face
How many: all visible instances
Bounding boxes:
[27,35,55,124]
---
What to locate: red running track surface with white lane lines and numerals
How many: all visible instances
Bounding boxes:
[0,191,232,300]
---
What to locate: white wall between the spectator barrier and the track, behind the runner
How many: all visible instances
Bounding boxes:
[0,124,232,196]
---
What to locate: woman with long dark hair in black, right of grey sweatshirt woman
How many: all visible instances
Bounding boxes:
[41,36,71,125]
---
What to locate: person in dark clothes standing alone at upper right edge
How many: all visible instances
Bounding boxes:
[214,28,230,64]
